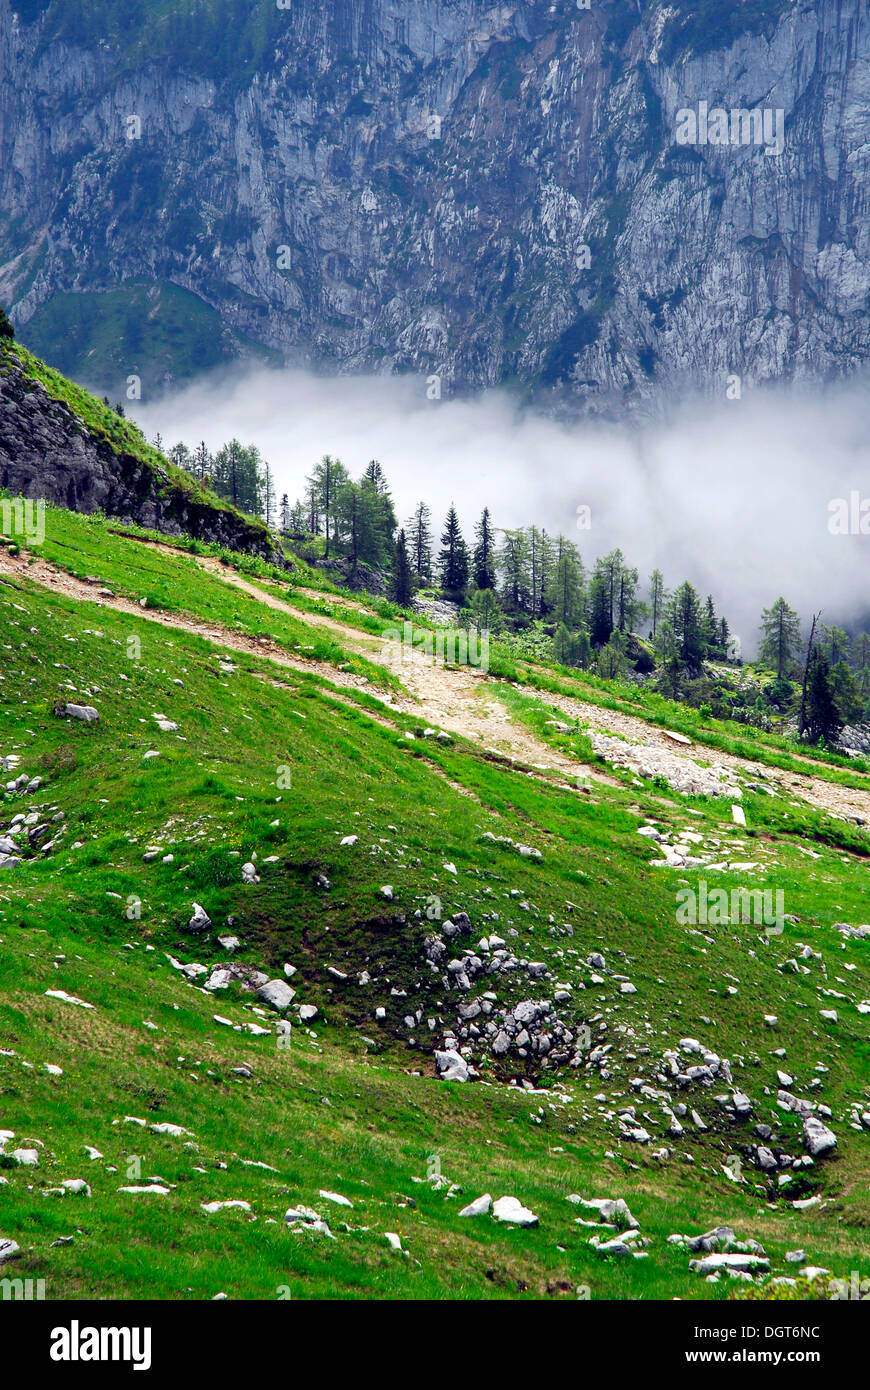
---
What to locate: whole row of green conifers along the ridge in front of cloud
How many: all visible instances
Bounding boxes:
[161,436,870,741]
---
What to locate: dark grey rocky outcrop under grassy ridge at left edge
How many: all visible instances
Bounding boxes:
[0,366,284,564]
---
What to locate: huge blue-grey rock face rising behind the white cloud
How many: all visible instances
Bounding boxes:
[0,0,870,411]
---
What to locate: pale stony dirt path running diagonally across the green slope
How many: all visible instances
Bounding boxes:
[6,542,870,820]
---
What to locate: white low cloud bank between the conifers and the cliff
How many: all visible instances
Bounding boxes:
[135,368,870,652]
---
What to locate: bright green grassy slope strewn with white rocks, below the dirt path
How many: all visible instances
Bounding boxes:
[0,518,870,1298]
